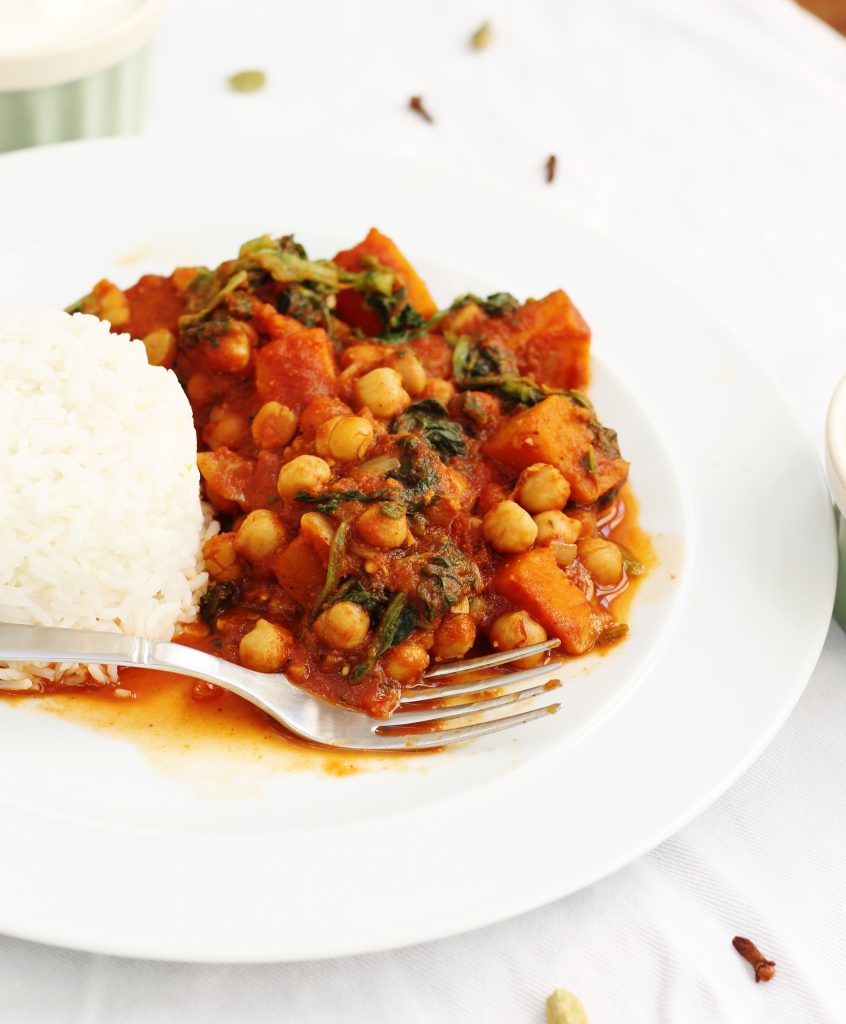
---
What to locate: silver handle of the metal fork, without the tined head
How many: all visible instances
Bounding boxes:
[0,623,293,713]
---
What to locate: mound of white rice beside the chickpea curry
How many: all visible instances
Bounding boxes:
[0,310,206,690]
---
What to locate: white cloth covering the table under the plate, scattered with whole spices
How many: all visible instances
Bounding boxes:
[0,0,846,1024]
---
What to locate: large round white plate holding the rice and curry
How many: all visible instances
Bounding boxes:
[0,141,836,961]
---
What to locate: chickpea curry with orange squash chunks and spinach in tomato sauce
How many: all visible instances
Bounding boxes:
[73,229,642,717]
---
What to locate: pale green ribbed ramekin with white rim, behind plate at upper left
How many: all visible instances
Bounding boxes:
[0,0,167,153]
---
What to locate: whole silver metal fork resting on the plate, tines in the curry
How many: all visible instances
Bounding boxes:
[0,623,562,751]
